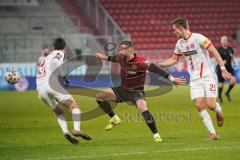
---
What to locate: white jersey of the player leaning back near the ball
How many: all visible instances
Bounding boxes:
[36,50,64,88]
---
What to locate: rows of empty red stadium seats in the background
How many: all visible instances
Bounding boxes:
[100,0,240,49]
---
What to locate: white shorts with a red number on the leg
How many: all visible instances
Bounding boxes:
[190,78,218,100]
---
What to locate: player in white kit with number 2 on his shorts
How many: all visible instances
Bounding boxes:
[159,17,231,140]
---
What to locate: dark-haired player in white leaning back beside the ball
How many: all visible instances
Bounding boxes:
[36,38,91,144]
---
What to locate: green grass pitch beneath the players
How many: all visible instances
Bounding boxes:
[0,86,240,160]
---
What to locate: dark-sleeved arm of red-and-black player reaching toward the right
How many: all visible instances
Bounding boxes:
[148,63,187,85]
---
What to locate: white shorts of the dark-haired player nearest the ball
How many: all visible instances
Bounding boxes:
[37,83,75,110]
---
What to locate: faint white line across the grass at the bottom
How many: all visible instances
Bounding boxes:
[26,146,240,160]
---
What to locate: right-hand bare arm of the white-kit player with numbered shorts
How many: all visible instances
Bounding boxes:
[207,45,232,80]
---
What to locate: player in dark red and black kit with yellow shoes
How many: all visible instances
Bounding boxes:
[96,41,186,142]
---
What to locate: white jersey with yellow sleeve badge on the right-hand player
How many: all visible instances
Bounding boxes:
[174,33,216,81]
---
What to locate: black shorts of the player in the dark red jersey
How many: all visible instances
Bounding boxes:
[112,86,145,105]
